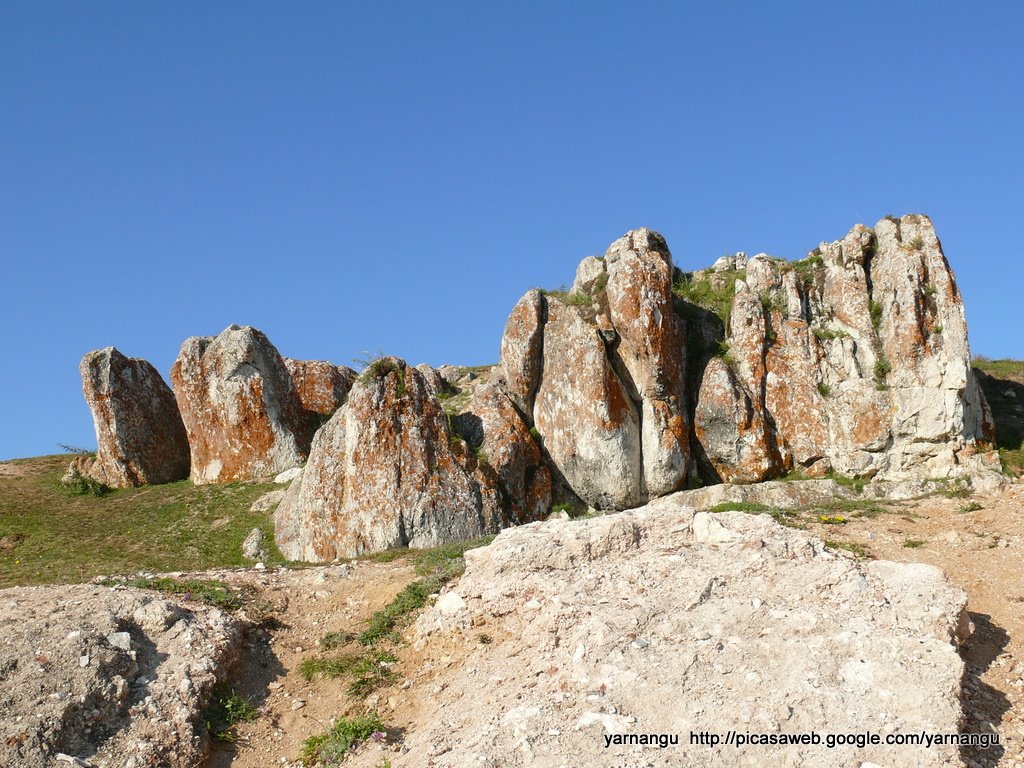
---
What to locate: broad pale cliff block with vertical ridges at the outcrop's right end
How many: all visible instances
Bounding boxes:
[695,216,991,478]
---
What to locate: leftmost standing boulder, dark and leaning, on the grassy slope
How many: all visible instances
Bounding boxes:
[78,347,188,487]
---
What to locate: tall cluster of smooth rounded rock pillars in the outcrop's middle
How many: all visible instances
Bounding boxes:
[501,229,690,509]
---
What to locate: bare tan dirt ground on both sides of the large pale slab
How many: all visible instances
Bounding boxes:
[193,483,1024,768]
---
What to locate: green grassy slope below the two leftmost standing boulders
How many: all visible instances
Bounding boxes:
[0,455,282,588]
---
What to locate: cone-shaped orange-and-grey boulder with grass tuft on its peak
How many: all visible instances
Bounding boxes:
[274,357,503,560]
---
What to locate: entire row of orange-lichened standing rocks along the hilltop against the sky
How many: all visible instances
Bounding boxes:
[76,215,994,559]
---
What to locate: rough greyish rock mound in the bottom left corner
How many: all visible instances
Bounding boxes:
[0,585,241,768]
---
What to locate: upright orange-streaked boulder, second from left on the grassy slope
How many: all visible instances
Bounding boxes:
[171,326,311,483]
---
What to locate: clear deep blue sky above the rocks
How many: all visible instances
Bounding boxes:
[0,0,1024,459]
